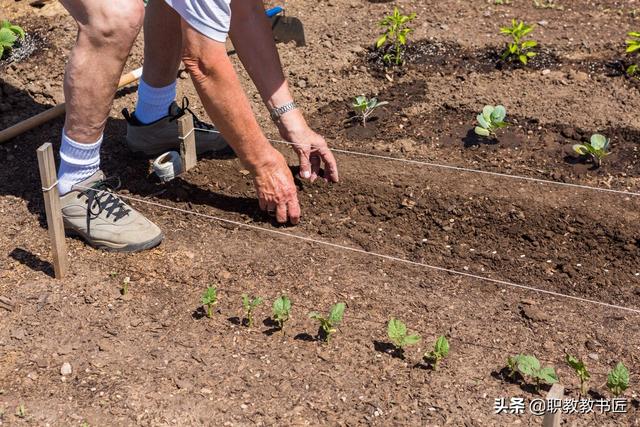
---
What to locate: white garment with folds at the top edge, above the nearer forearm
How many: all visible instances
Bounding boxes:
[164,0,231,43]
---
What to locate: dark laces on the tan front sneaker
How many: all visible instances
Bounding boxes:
[78,178,131,234]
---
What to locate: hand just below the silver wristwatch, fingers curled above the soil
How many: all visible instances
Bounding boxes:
[278,110,339,182]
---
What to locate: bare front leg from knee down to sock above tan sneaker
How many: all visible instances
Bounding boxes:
[61,0,144,143]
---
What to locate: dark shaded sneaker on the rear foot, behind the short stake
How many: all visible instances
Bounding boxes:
[122,98,233,158]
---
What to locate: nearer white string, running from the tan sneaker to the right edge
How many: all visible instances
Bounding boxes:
[76,185,640,314]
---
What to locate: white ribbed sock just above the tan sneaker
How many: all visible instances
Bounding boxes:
[58,129,102,196]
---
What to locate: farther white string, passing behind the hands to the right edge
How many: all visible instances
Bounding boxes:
[196,128,640,196]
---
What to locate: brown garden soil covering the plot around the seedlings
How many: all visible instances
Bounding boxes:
[0,0,640,426]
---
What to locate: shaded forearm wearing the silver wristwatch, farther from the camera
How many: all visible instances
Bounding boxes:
[229,0,293,112]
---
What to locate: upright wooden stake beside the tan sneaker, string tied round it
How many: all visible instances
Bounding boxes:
[37,142,69,279]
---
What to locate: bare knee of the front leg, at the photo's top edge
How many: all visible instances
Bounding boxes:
[81,0,144,47]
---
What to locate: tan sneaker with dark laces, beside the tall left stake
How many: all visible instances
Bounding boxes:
[60,171,164,252]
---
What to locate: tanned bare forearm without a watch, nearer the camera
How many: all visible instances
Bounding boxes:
[183,28,273,171]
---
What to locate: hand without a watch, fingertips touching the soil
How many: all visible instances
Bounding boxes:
[253,149,300,225]
